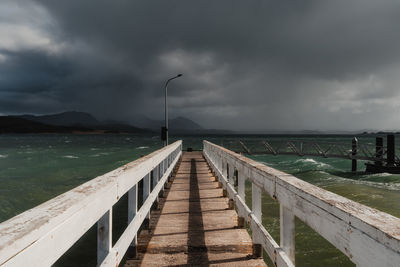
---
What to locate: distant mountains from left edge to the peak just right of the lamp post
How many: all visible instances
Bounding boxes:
[0,111,229,135]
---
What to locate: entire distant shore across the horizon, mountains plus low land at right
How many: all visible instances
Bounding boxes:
[0,111,394,135]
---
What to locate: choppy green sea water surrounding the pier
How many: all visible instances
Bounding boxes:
[0,134,400,267]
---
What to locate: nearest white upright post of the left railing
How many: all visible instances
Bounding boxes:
[97,209,112,266]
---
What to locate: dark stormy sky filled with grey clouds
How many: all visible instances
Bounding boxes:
[0,0,400,130]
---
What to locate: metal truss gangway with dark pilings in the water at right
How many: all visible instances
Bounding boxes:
[223,134,400,173]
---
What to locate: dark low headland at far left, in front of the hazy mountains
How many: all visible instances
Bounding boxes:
[0,116,90,134]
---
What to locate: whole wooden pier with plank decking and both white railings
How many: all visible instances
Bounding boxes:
[0,141,400,267]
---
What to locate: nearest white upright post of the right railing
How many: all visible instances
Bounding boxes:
[280,204,295,264]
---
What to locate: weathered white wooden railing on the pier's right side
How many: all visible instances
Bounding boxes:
[203,141,400,267]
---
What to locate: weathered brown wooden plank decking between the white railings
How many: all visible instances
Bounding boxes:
[125,152,266,267]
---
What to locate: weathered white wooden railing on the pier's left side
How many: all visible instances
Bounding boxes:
[0,141,182,267]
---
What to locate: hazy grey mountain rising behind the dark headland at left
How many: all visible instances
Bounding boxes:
[17,111,99,127]
